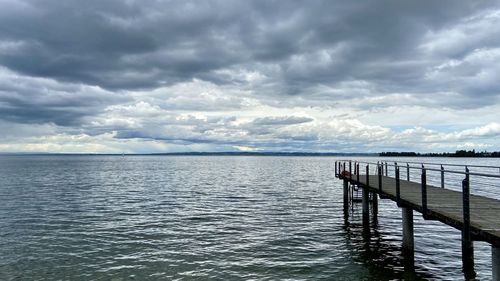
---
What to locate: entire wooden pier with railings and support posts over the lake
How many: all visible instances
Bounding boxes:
[335,161,500,281]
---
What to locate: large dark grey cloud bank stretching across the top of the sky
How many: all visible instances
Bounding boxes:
[0,1,496,89]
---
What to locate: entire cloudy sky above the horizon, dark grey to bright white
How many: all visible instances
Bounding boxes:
[0,0,500,153]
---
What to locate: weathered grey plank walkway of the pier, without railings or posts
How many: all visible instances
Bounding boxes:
[339,175,500,247]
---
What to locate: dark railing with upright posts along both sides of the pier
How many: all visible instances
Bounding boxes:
[335,160,500,235]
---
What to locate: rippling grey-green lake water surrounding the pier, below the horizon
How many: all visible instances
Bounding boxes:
[0,156,500,280]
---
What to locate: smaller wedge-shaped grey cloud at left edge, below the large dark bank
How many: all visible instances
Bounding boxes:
[0,68,128,126]
